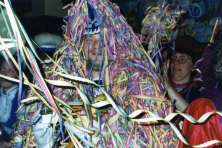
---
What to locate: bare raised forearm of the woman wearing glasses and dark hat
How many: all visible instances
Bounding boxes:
[161,60,188,111]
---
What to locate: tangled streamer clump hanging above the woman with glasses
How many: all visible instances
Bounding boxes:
[140,3,186,72]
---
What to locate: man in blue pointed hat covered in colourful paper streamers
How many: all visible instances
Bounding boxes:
[12,0,182,147]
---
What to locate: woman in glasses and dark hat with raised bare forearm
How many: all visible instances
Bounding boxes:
[162,47,195,111]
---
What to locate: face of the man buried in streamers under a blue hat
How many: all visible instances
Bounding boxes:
[83,34,102,71]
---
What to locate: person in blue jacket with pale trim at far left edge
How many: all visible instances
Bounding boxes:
[0,56,18,148]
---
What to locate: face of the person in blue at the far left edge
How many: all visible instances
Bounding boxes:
[0,61,18,90]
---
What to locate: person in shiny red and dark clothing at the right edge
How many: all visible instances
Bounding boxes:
[178,49,222,148]
